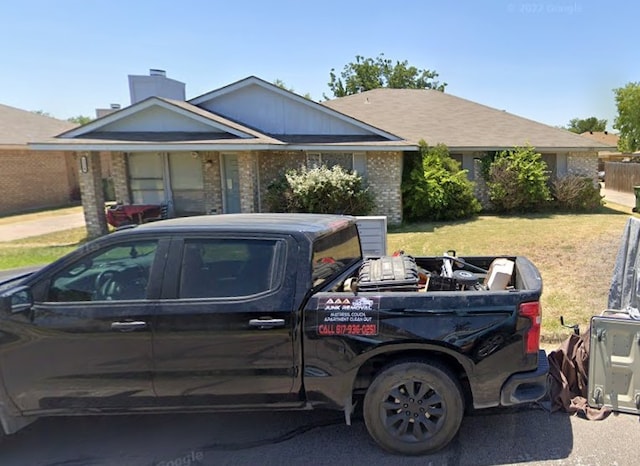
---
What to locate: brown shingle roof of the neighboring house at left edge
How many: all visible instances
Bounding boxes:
[0,104,77,146]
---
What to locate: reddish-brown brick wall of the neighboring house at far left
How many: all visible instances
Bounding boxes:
[0,149,78,214]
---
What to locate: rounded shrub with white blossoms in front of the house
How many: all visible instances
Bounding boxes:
[265,165,374,215]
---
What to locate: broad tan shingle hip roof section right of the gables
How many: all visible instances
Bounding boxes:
[323,88,611,151]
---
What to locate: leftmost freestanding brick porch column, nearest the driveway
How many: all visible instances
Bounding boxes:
[77,152,108,239]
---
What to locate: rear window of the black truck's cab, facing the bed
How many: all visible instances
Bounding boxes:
[312,224,362,287]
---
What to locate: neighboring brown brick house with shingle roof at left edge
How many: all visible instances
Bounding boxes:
[0,104,80,215]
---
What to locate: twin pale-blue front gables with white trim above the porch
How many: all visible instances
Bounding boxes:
[31,76,411,151]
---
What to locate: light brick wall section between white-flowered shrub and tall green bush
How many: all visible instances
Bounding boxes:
[367,152,402,225]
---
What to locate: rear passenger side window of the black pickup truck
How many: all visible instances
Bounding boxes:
[178,239,278,298]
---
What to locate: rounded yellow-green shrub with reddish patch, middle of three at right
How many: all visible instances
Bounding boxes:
[487,145,552,212]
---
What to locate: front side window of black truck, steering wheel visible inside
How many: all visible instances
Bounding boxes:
[48,241,157,302]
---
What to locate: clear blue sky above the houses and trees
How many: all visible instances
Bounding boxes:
[0,0,640,130]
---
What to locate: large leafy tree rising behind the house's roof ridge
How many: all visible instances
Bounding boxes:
[325,53,447,98]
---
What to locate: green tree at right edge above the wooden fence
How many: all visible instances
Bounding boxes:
[613,82,640,152]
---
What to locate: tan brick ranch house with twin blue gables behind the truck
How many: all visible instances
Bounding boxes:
[32,70,603,236]
